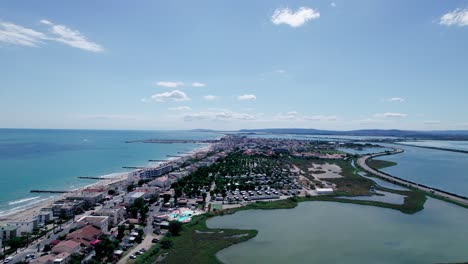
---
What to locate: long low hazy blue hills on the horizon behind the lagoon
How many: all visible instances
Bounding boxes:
[239,128,468,140]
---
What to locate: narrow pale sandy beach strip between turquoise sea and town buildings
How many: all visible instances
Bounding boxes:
[0,143,214,223]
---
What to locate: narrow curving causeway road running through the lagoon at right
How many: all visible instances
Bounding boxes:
[358,149,468,205]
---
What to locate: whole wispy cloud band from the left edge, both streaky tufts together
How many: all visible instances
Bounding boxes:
[0,20,104,52]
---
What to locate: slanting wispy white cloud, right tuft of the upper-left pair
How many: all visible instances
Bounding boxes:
[40,19,104,52]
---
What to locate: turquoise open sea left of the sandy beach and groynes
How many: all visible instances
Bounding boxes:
[0,129,221,216]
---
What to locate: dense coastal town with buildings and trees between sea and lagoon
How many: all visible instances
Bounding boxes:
[0,135,438,264]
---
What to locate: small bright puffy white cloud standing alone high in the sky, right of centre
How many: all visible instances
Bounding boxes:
[271,7,320,27]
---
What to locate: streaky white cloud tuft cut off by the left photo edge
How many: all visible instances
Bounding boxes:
[0,22,48,47]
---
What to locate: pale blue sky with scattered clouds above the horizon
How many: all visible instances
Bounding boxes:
[0,0,468,130]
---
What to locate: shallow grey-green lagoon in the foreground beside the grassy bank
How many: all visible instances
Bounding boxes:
[208,199,468,264]
